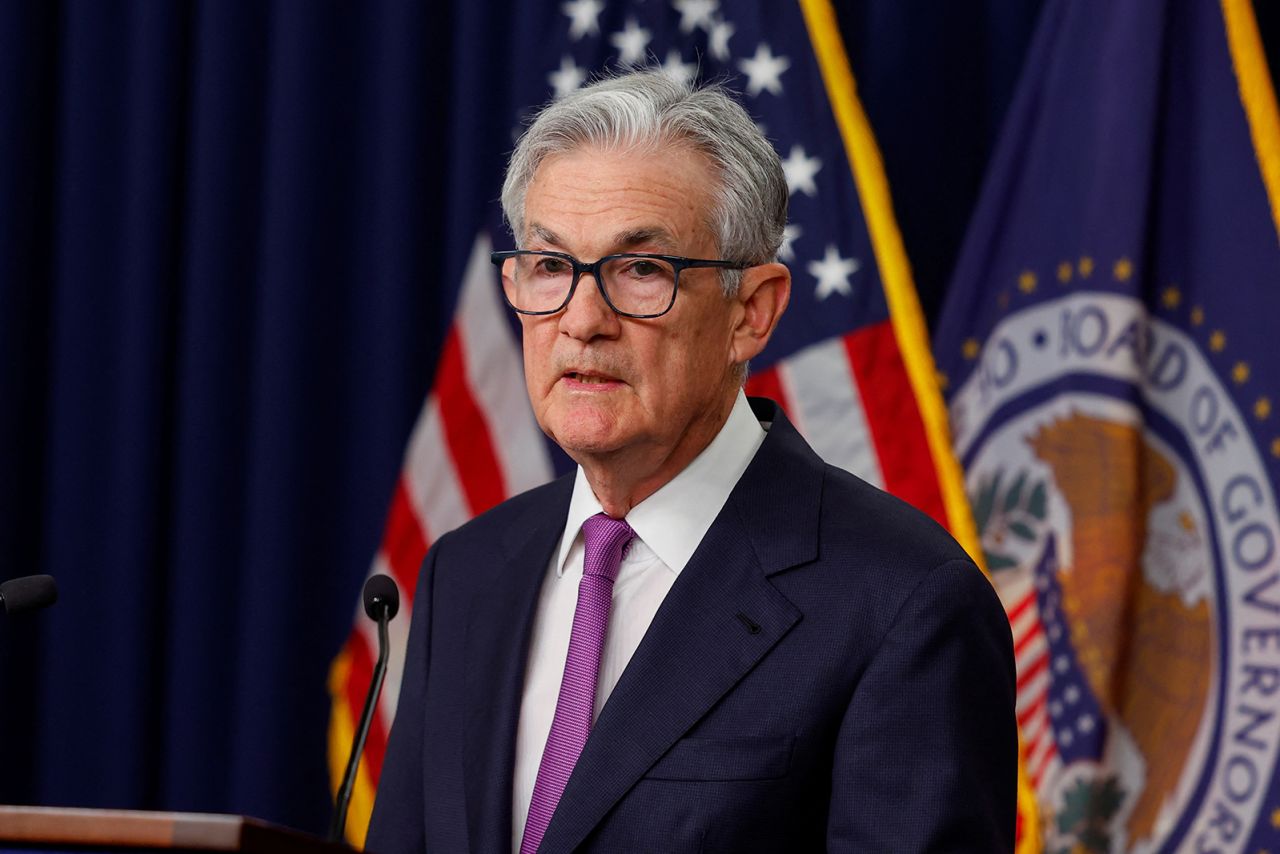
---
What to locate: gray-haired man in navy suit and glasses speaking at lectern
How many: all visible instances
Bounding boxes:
[367,73,1018,854]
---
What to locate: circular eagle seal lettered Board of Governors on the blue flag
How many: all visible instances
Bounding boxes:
[950,291,1280,853]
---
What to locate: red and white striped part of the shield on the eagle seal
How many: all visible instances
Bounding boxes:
[1001,580,1062,790]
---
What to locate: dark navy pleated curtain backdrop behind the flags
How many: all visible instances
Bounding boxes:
[0,0,1280,831]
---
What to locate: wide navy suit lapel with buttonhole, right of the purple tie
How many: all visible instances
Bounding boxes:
[539,412,822,851]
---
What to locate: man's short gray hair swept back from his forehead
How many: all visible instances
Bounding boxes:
[502,69,790,293]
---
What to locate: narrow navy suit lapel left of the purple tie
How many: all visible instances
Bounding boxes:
[462,478,573,853]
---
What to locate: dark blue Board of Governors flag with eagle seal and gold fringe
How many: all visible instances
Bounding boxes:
[936,0,1280,854]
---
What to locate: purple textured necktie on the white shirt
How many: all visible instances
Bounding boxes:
[520,513,636,854]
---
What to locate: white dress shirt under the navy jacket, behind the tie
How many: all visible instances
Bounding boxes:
[511,392,764,853]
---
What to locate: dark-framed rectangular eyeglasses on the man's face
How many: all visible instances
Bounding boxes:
[489,250,751,319]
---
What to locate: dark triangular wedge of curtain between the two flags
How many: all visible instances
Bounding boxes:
[835,0,1043,326]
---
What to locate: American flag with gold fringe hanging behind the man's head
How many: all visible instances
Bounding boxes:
[329,0,1025,844]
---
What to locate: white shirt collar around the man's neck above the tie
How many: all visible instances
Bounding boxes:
[556,391,764,576]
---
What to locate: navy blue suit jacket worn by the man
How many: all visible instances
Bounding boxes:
[367,401,1018,854]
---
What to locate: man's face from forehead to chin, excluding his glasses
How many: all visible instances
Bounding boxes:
[520,147,740,476]
